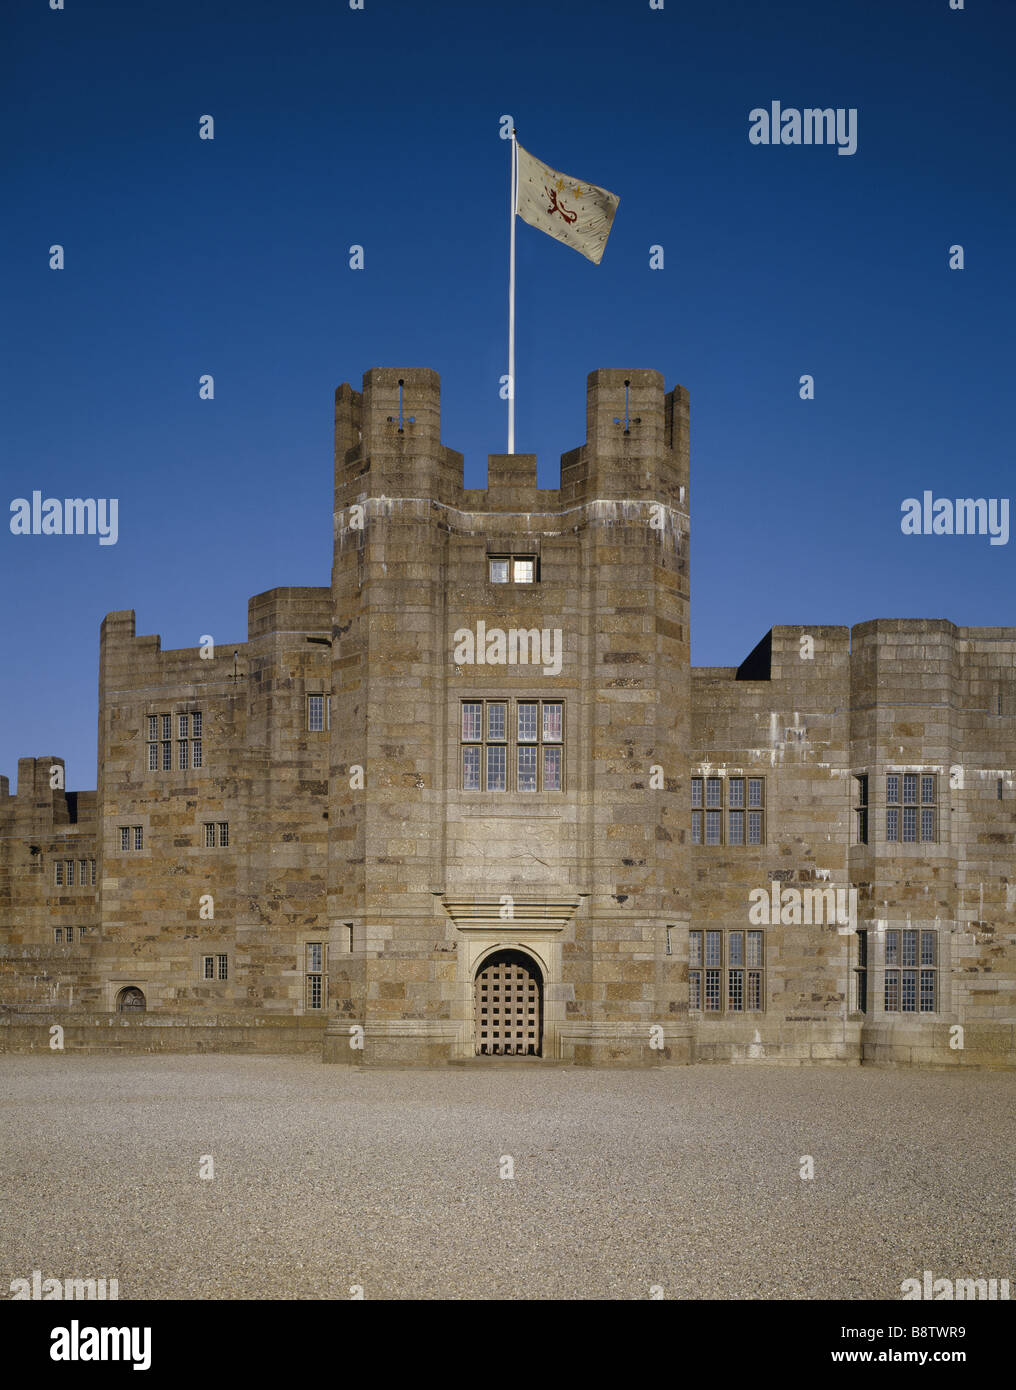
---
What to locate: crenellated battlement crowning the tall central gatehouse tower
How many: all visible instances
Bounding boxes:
[335,367,688,512]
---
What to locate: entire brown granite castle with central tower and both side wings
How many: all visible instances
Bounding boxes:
[0,368,1016,1066]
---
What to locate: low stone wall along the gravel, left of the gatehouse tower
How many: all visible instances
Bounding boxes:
[0,1009,325,1056]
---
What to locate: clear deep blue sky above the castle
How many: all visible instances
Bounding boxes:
[0,0,1016,788]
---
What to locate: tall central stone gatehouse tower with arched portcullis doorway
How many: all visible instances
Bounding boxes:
[327,370,689,1061]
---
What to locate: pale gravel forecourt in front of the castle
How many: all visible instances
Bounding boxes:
[0,1055,1016,1298]
